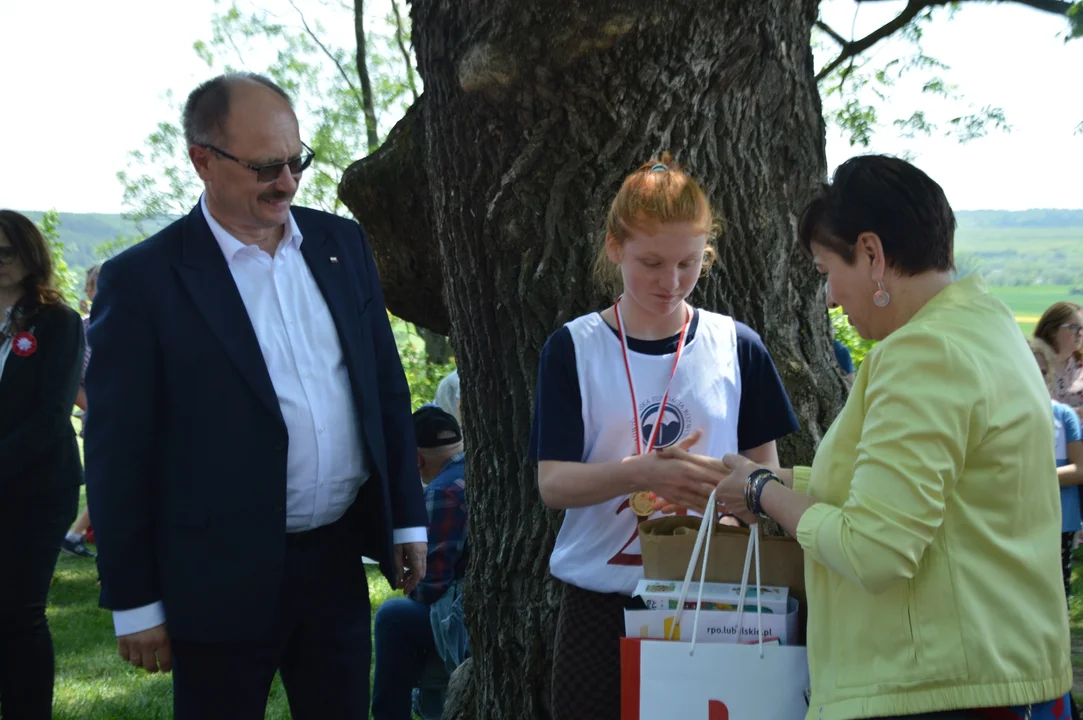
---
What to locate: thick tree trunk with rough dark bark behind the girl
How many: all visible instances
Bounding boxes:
[340,0,841,719]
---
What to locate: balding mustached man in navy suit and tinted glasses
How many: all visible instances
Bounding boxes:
[86,74,427,720]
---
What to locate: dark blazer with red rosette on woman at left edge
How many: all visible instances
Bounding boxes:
[0,304,83,500]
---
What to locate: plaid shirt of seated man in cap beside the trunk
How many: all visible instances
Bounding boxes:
[410,453,468,605]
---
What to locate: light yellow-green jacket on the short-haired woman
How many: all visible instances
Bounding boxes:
[794,276,1072,720]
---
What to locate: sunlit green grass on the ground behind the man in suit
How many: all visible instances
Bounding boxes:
[48,485,401,720]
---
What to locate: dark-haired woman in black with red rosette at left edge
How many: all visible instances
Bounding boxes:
[0,210,83,720]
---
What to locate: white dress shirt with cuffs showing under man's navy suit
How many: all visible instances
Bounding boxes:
[113,198,428,636]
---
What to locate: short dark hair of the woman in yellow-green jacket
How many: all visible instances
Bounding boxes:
[797,155,955,275]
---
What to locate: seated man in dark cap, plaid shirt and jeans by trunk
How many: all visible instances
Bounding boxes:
[373,405,467,720]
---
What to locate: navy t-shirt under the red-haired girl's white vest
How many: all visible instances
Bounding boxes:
[529,310,800,462]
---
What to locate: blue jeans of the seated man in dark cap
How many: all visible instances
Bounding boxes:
[373,598,439,720]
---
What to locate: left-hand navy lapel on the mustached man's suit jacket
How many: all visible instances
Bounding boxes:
[177,205,282,419]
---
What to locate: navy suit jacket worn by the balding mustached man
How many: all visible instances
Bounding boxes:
[83,206,428,642]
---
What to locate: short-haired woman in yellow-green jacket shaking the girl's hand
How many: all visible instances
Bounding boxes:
[666,156,1072,720]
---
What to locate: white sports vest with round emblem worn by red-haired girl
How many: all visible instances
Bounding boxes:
[549,310,741,595]
